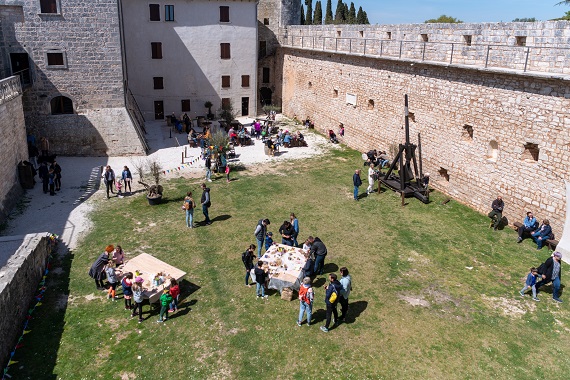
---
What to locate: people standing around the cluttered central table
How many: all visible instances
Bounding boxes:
[242,217,352,332]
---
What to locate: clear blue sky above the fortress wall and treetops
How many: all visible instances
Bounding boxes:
[332,0,570,24]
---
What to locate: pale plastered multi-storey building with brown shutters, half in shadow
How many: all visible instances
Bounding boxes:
[122,0,257,120]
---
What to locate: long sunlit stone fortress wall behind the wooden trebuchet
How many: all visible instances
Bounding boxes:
[276,23,570,237]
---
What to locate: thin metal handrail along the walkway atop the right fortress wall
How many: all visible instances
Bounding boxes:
[278,33,570,74]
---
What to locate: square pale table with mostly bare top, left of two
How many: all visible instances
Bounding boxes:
[121,253,186,303]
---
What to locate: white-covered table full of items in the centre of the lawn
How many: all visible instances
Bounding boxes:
[252,244,307,293]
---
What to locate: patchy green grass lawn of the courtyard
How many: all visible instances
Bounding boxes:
[10,149,570,379]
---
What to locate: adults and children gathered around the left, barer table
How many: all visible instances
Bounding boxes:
[89,244,180,323]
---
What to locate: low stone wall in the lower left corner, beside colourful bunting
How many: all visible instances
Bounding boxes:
[0,233,51,368]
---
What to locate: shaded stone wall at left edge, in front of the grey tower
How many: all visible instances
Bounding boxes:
[0,77,28,223]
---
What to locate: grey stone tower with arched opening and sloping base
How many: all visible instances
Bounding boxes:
[0,0,146,156]
